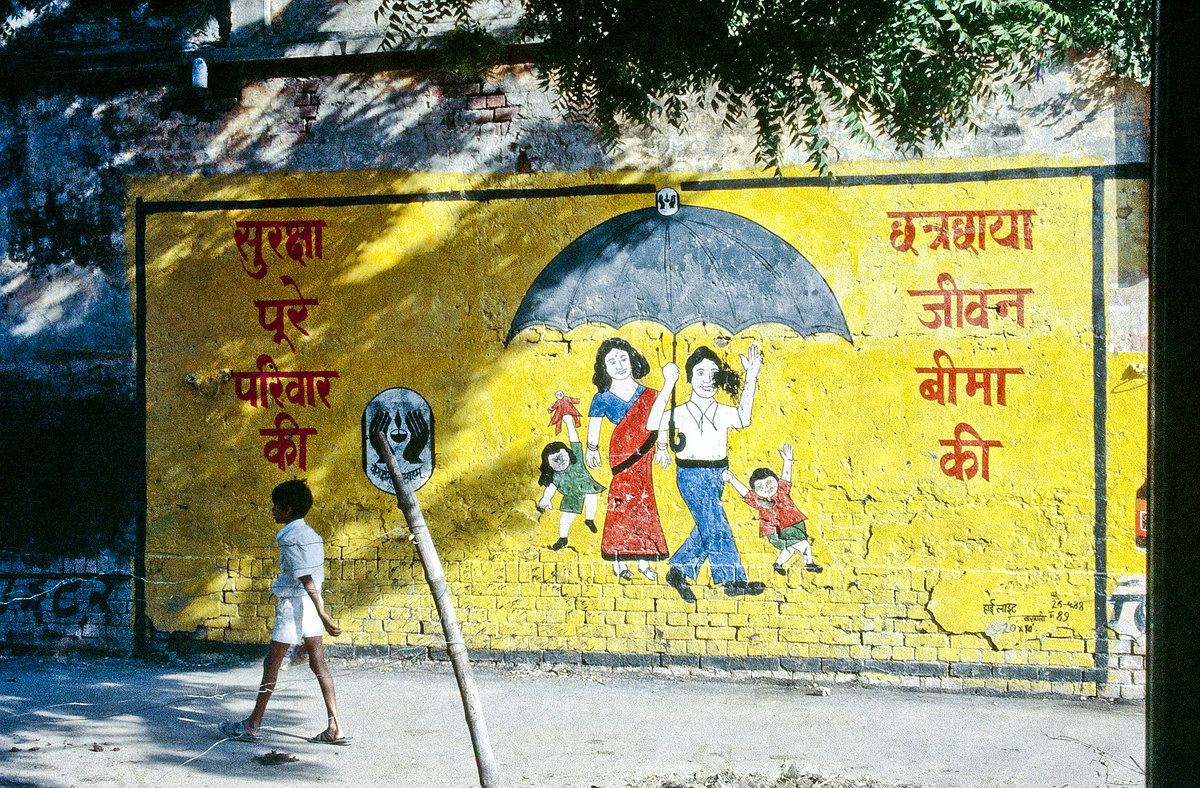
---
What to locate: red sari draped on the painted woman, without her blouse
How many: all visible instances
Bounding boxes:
[600,389,667,561]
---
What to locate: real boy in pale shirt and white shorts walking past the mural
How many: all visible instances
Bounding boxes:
[218,480,350,745]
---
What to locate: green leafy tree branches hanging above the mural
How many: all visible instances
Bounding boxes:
[378,0,1151,175]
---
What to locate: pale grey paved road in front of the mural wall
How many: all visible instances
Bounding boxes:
[0,658,1144,788]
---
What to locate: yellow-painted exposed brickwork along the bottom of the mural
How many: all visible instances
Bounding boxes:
[194,548,1145,699]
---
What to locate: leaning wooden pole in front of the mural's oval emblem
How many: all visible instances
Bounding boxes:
[371,431,500,788]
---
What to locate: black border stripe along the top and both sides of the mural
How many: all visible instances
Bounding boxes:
[133,162,1151,684]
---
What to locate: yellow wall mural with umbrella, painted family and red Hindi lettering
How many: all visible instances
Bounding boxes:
[128,162,1145,681]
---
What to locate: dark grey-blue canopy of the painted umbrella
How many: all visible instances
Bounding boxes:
[505,200,853,343]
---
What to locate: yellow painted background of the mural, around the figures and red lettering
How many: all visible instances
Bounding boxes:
[130,160,1145,688]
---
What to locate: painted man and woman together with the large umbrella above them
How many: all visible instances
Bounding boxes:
[508,187,851,602]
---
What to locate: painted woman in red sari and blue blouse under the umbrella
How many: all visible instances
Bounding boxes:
[583,337,671,581]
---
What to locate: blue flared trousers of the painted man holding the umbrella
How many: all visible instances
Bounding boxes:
[671,468,746,583]
